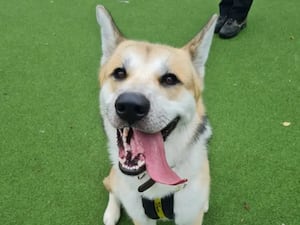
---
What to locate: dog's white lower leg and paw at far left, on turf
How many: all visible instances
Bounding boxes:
[103,194,121,225]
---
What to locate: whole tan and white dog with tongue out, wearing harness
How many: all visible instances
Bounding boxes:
[96,6,217,225]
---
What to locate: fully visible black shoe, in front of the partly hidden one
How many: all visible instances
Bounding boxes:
[219,18,247,38]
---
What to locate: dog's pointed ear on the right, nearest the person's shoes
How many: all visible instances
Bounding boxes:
[183,14,218,78]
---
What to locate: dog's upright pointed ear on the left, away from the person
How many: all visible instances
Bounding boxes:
[96,5,124,65]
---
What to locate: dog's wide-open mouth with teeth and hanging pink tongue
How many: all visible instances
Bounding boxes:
[117,117,186,185]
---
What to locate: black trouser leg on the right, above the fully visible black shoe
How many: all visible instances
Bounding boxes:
[229,0,253,22]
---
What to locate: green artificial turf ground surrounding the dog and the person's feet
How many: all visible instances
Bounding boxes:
[0,0,300,225]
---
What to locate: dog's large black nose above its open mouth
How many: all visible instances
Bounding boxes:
[115,92,150,125]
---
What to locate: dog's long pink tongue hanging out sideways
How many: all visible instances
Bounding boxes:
[131,130,187,185]
